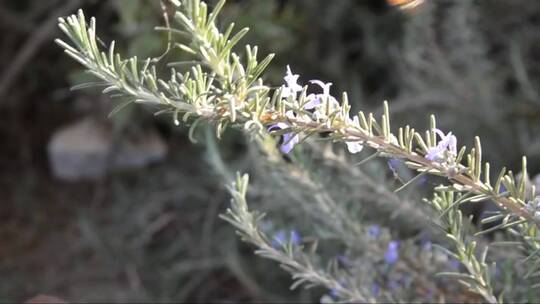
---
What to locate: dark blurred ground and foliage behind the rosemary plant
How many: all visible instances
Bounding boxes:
[0,0,540,302]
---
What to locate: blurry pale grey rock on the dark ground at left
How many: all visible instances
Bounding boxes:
[47,118,167,181]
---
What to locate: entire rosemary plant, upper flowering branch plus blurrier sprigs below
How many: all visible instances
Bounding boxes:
[56,0,540,302]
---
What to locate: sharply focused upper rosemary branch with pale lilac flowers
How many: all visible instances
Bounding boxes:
[56,0,540,300]
